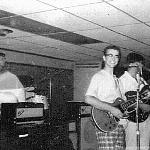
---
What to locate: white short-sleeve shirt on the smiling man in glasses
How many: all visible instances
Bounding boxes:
[86,70,121,103]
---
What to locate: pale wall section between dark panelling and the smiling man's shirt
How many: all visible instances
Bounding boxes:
[74,63,100,101]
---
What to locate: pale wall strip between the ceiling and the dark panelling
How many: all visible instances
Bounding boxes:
[0,50,74,69]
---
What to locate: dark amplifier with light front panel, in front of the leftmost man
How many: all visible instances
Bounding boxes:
[1,102,44,127]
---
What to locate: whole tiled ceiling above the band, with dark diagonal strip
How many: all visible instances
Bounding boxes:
[0,0,150,67]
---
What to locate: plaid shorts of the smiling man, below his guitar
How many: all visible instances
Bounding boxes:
[96,125,125,150]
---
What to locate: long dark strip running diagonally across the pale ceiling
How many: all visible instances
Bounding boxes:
[0,12,101,45]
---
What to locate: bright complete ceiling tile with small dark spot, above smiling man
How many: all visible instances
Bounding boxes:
[62,3,137,27]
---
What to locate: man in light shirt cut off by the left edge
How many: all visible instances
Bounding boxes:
[0,53,25,112]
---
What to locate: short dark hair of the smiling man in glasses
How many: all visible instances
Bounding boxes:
[101,45,121,69]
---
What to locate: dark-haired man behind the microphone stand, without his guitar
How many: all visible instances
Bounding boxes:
[120,53,150,150]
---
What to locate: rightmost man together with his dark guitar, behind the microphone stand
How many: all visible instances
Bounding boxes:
[120,53,150,150]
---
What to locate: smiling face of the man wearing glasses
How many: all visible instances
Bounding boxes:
[103,49,120,68]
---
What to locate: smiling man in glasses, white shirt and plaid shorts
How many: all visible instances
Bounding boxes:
[85,46,125,150]
